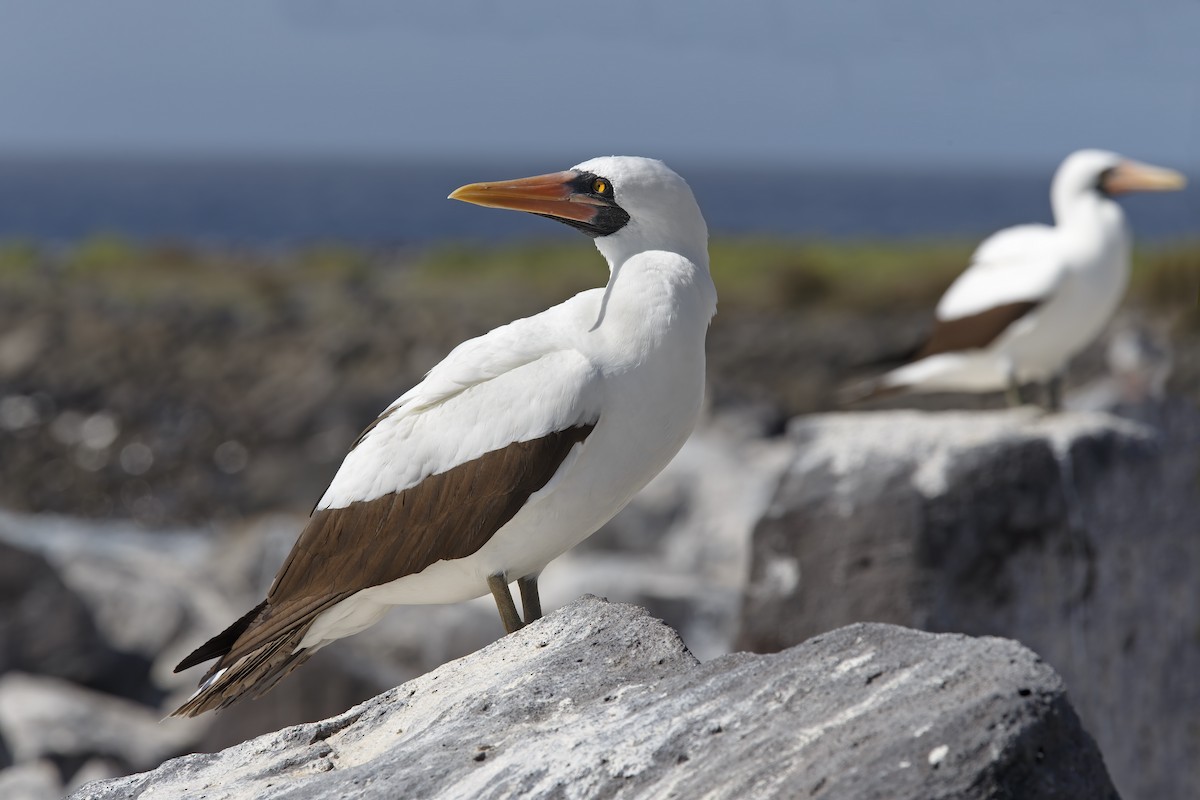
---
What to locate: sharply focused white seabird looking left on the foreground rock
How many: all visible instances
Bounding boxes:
[174,157,716,716]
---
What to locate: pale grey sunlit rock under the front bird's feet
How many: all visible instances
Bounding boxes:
[73,597,1115,800]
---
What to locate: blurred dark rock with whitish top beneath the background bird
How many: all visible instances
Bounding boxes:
[738,408,1200,798]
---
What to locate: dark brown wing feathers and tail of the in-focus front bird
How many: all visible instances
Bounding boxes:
[172,425,595,716]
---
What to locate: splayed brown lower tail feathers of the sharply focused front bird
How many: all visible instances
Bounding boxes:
[170,625,313,717]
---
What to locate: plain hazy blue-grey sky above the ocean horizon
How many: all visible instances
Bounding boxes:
[0,0,1200,167]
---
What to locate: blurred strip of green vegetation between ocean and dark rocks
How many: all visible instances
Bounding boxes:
[9,234,1200,317]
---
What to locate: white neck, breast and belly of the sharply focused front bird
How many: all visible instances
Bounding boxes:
[350,253,715,604]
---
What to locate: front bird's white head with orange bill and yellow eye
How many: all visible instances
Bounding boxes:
[450,156,708,267]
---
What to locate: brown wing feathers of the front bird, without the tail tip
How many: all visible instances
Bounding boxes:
[222,425,595,662]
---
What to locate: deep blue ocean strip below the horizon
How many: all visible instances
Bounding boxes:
[0,158,1200,247]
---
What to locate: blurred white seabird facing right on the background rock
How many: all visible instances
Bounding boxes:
[853,150,1186,408]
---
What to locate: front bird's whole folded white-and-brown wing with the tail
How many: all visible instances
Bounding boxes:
[175,320,602,715]
